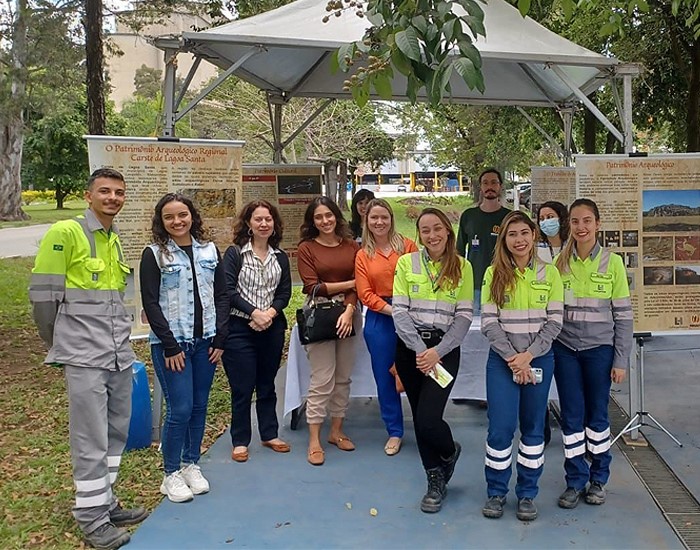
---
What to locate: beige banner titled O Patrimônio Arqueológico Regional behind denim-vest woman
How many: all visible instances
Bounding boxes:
[86,136,243,335]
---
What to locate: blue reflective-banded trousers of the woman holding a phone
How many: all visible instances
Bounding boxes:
[484,349,554,498]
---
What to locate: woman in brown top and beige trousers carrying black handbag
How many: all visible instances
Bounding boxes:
[297,197,361,466]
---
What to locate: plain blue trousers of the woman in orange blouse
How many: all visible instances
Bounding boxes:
[364,310,403,437]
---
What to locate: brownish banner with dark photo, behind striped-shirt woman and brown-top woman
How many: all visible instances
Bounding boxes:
[243,164,323,283]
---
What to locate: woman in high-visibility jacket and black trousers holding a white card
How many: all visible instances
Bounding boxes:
[392,208,474,513]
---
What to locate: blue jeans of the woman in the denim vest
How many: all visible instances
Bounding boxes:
[151,338,216,475]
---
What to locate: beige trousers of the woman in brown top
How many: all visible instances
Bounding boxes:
[305,315,362,424]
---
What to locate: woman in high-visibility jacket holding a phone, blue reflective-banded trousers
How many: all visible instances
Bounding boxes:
[481,212,563,521]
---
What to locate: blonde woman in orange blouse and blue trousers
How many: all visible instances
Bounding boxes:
[355,199,418,456]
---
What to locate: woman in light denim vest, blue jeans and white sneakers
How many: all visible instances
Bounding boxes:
[140,193,228,502]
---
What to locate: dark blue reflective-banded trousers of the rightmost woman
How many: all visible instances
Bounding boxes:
[552,341,614,491]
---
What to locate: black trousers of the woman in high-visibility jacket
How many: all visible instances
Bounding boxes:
[396,337,460,470]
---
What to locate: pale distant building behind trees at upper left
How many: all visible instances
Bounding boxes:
[105,12,217,110]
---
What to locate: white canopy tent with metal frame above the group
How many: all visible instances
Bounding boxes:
[155,0,640,162]
